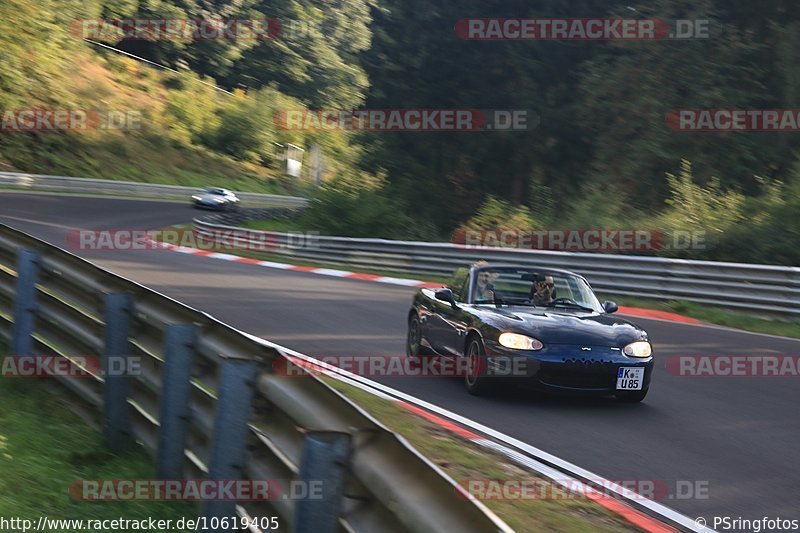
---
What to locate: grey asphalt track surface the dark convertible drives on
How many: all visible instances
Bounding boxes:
[0,192,800,523]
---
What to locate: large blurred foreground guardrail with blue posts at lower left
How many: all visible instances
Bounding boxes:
[0,225,509,532]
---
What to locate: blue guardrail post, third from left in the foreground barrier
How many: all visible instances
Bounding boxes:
[156,324,197,479]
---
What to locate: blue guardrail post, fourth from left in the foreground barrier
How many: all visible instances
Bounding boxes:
[203,358,258,531]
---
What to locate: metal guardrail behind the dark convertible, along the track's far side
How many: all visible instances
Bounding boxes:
[194,215,800,316]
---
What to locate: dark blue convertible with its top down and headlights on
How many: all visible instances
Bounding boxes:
[406,265,653,402]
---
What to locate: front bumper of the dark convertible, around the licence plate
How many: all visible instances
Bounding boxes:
[485,342,654,395]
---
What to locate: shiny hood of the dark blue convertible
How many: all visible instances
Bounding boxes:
[484,306,648,347]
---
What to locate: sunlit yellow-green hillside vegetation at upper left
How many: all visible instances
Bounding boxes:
[0,0,369,191]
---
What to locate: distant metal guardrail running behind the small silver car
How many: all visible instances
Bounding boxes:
[0,172,306,207]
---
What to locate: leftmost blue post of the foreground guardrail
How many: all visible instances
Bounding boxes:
[11,249,39,355]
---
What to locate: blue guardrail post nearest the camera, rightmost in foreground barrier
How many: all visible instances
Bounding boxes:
[290,431,350,533]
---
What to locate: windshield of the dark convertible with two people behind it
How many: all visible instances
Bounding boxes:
[471,267,603,312]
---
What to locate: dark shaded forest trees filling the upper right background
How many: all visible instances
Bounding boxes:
[364,0,800,254]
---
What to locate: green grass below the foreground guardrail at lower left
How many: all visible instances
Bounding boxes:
[0,368,199,520]
